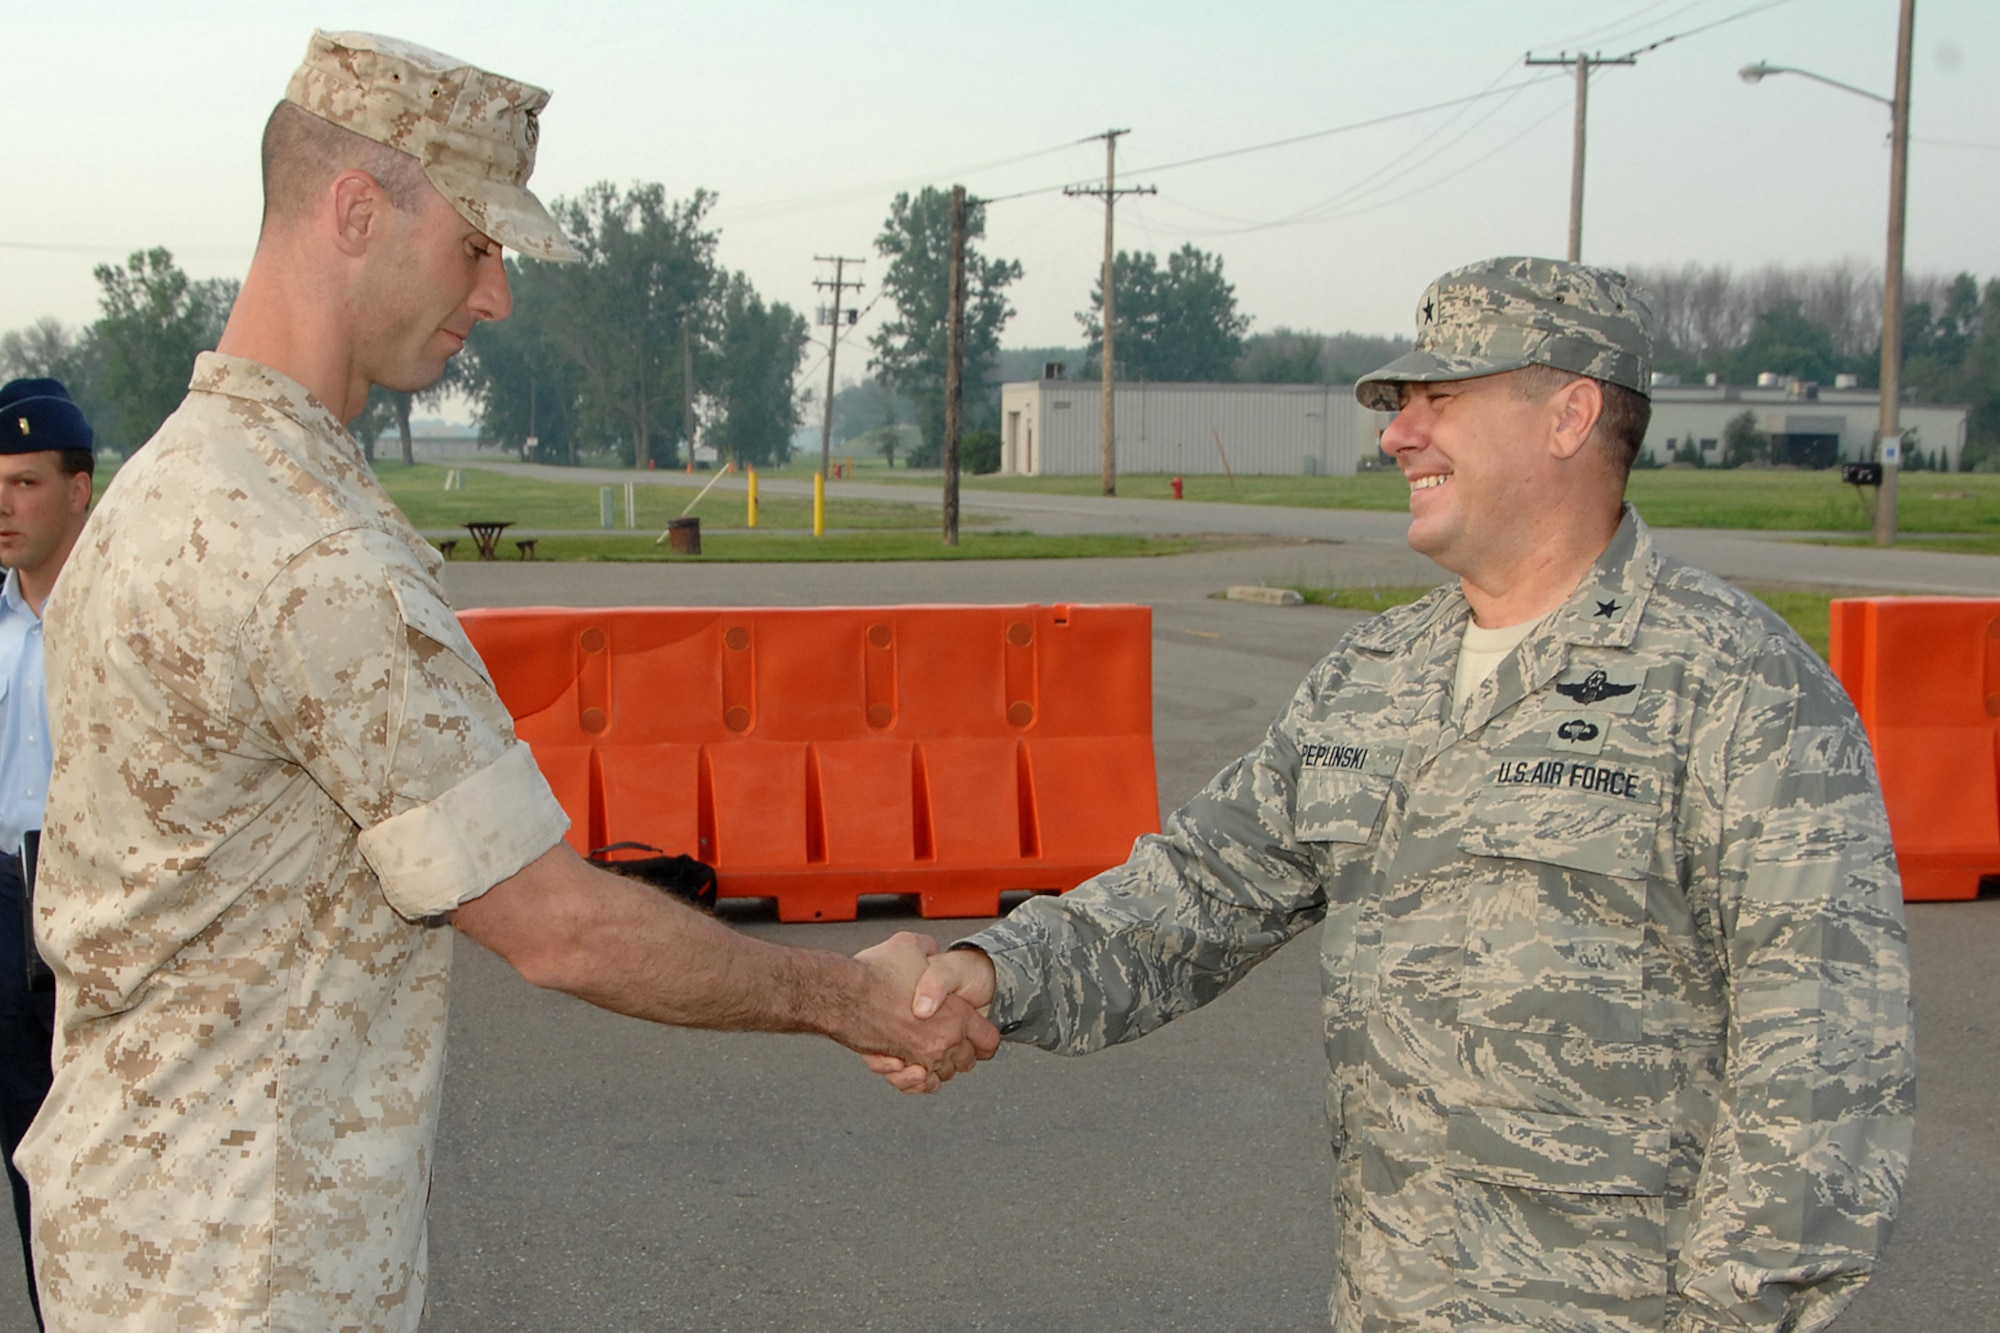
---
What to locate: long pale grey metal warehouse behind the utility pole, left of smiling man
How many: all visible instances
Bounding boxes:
[1000,380,1388,476]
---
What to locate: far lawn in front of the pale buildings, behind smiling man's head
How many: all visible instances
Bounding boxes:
[940,468,2000,532]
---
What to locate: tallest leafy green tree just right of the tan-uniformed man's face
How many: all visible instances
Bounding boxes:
[540,182,720,466]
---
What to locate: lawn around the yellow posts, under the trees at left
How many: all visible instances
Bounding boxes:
[376,462,938,534]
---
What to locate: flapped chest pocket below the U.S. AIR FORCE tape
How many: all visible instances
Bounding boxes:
[1458,789,1660,1041]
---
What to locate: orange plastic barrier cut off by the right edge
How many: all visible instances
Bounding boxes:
[1832,596,2000,901]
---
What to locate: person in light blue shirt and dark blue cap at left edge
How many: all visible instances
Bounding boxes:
[0,378,96,1323]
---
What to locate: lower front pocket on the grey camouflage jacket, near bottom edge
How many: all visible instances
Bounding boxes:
[1446,1107,1668,1304]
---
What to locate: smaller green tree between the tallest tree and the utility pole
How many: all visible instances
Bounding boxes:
[704,274,808,464]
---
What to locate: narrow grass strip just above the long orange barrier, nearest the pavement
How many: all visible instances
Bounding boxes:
[452,516,1212,564]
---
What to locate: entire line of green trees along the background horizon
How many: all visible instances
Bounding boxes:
[0,200,2000,468]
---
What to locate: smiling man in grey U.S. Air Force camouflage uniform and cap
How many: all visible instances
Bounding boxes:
[872,258,1914,1333]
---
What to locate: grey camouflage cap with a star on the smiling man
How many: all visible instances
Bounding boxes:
[1354,256,1654,412]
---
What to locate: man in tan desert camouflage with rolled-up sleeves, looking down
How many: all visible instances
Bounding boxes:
[20,34,998,1333]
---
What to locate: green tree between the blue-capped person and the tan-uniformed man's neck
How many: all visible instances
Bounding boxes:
[90,248,238,448]
